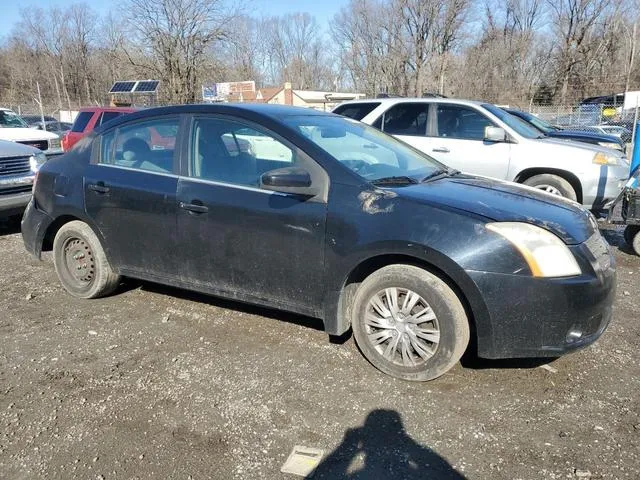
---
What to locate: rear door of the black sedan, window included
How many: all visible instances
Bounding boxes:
[84,116,181,281]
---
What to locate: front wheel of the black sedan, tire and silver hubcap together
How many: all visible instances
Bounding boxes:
[351,265,469,381]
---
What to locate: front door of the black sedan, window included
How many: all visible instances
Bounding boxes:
[177,115,328,315]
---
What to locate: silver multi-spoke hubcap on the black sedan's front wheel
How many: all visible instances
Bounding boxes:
[365,288,440,367]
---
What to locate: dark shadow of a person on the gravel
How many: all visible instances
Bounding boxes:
[313,409,465,480]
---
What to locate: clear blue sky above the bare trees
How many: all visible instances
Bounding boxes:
[0,0,348,38]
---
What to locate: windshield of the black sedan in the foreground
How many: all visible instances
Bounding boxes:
[284,115,448,183]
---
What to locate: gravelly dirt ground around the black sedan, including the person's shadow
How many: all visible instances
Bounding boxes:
[0,218,640,479]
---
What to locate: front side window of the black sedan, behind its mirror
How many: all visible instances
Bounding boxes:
[189,118,297,187]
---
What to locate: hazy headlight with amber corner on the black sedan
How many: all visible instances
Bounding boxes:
[486,222,582,277]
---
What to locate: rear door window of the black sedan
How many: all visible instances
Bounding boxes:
[98,117,180,173]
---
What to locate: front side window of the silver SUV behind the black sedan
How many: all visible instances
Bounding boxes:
[436,104,495,141]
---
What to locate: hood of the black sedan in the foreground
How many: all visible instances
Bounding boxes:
[394,174,597,245]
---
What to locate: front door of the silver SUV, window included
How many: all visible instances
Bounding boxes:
[423,102,511,180]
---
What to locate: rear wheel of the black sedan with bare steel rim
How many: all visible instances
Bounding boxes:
[53,220,120,298]
